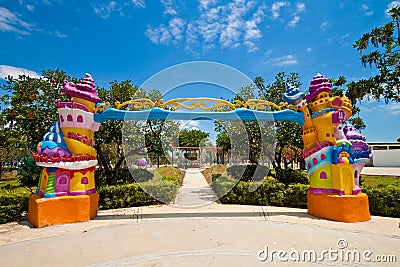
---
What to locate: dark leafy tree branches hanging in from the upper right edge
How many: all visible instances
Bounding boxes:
[349,6,400,102]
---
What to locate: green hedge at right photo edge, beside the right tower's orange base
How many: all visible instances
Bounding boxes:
[362,185,400,218]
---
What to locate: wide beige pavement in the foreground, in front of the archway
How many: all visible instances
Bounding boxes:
[0,205,400,266]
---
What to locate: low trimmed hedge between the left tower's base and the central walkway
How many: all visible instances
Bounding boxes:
[97,181,179,209]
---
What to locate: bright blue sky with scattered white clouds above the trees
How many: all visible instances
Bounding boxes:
[0,0,400,142]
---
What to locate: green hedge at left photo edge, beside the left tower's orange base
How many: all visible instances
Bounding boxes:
[0,191,29,223]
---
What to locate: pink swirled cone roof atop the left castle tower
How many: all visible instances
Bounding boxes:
[64,73,101,103]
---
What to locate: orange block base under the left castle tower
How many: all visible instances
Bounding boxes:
[28,193,99,227]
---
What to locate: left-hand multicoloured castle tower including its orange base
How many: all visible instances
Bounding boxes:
[28,74,100,227]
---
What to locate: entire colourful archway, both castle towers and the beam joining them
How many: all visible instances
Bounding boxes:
[28,74,371,227]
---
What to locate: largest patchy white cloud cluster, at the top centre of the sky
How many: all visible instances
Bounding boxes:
[145,0,266,53]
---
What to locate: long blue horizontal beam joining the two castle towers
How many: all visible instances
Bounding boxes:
[94,107,304,126]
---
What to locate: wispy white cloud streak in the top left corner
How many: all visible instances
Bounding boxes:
[0,7,35,35]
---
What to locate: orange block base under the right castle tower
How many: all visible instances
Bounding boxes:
[307,192,371,222]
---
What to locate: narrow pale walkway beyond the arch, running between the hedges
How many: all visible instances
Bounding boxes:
[174,168,218,208]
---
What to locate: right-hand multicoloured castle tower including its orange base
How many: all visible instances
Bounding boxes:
[283,74,370,222]
